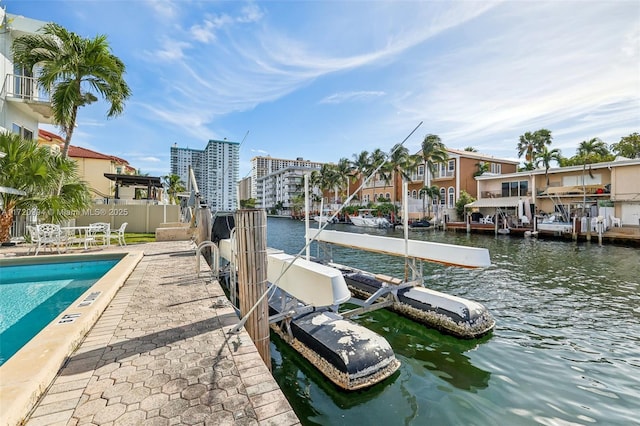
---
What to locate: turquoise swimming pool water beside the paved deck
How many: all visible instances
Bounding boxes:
[0,259,119,365]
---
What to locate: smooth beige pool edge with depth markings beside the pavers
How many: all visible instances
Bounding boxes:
[0,250,144,425]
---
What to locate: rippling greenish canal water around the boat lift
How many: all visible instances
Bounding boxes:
[267,218,640,425]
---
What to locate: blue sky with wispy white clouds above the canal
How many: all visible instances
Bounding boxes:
[0,0,640,176]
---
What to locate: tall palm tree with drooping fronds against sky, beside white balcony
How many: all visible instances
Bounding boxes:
[13,23,131,158]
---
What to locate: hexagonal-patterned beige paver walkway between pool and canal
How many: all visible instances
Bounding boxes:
[0,242,300,426]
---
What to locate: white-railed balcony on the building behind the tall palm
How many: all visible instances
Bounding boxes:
[0,74,53,124]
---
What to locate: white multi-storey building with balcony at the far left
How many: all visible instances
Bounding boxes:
[0,8,53,139]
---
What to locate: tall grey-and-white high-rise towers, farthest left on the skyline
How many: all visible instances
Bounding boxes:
[171,139,240,212]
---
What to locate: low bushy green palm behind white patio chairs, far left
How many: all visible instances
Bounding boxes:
[0,133,91,242]
